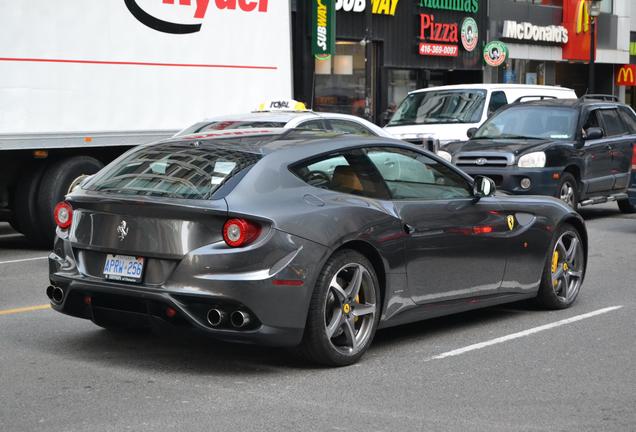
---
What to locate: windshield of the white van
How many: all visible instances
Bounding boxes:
[387,90,486,126]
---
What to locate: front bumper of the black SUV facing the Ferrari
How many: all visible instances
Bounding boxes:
[459,166,563,196]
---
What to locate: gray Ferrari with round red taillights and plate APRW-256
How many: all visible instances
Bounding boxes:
[47,129,587,366]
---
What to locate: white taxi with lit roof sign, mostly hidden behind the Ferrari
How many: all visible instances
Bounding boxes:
[175,100,391,137]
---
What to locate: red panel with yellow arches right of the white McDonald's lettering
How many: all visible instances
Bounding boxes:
[563,0,596,61]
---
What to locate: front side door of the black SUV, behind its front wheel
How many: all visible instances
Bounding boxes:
[581,109,614,195]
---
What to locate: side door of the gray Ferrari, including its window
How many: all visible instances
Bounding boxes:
[367,147,508,304]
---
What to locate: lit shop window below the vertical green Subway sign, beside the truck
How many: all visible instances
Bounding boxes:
[313,41,374,117]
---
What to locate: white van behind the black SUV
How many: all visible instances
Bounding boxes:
[384,84,576,150]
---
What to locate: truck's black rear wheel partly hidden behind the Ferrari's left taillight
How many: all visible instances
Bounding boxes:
[38,156,104,244]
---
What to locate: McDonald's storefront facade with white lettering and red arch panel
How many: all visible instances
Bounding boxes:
[484,0,633,95]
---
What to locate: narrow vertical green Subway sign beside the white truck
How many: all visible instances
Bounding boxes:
[311,0,336,59]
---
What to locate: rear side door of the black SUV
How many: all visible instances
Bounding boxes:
[600,109,634,191]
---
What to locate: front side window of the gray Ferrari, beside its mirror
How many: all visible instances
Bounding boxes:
[367,147,472,200]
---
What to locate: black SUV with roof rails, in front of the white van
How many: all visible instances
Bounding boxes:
[438,95,636,211]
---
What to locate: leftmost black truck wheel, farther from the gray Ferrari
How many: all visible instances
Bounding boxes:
[11,164,46,246]
